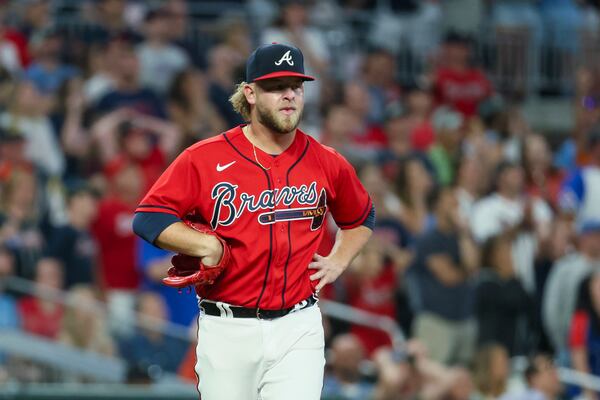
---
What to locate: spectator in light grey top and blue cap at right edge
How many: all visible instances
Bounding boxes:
[542,220,600,354]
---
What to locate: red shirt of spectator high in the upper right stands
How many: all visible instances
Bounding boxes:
[434,68,492,118]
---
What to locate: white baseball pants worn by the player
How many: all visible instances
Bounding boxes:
[196,304,325,400]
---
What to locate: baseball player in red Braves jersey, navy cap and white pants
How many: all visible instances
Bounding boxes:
[134,43,375,400]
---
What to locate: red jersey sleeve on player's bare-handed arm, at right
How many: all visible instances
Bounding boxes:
[328,152,373,229]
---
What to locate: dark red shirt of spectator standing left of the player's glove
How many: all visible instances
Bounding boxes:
[92,197,140,289]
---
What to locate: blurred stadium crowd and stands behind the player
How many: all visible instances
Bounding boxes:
[0,0,600,400]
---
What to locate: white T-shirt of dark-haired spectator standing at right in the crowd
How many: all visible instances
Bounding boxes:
[470,193,552,293]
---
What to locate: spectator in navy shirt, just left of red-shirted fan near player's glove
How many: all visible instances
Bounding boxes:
[45,182,98,289]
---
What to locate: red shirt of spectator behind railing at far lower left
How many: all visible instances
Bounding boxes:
[18,297,64,339]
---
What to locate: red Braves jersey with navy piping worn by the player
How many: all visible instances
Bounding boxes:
[136,126,372,309]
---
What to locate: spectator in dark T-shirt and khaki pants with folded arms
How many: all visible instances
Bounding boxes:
[408,188,479,365]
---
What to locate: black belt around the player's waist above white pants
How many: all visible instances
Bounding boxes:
[200,295,318,319]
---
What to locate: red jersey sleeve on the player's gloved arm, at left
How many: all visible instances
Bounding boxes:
[135,151,200,218]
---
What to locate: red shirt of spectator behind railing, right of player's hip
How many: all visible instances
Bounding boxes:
[347,264,396,356]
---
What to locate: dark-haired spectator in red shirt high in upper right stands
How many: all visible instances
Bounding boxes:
[433,34,493,119]
